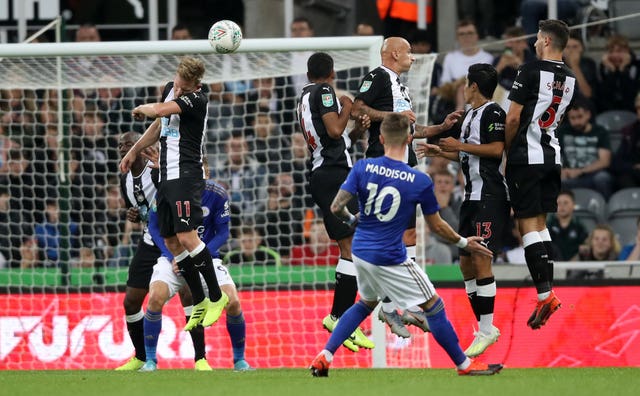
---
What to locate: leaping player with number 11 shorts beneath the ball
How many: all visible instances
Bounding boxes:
[120,57,229,331]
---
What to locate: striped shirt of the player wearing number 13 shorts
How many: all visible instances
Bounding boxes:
[459,102,507,201]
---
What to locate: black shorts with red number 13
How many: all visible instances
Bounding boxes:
[458,200,511,256]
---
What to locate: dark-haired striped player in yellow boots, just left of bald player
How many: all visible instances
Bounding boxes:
[297,52,374,352]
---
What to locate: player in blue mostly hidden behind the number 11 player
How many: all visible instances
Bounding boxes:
[140,163,253,371]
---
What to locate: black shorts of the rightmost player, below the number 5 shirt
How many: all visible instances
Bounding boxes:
[505,165,561,219]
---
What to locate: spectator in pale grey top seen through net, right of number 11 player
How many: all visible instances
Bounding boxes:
[211,131,266,219]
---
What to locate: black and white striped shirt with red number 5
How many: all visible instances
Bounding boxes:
[507,60,576,165]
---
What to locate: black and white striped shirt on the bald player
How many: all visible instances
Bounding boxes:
[356,66,417,166]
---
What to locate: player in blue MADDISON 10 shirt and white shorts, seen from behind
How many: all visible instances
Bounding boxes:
[310,113,502,377]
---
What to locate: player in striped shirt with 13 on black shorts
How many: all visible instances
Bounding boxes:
[418,63,509,357]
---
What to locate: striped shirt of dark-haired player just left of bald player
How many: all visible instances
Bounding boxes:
[298,83,353,171]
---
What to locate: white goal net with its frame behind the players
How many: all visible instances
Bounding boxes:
[0,37,440,369]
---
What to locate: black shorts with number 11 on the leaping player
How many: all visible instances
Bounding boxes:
[156,178,205,238]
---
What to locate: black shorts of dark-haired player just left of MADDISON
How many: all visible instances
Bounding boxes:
[309,166,358,241]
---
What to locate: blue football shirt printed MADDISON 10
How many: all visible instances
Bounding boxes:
[341,156,440,265]
